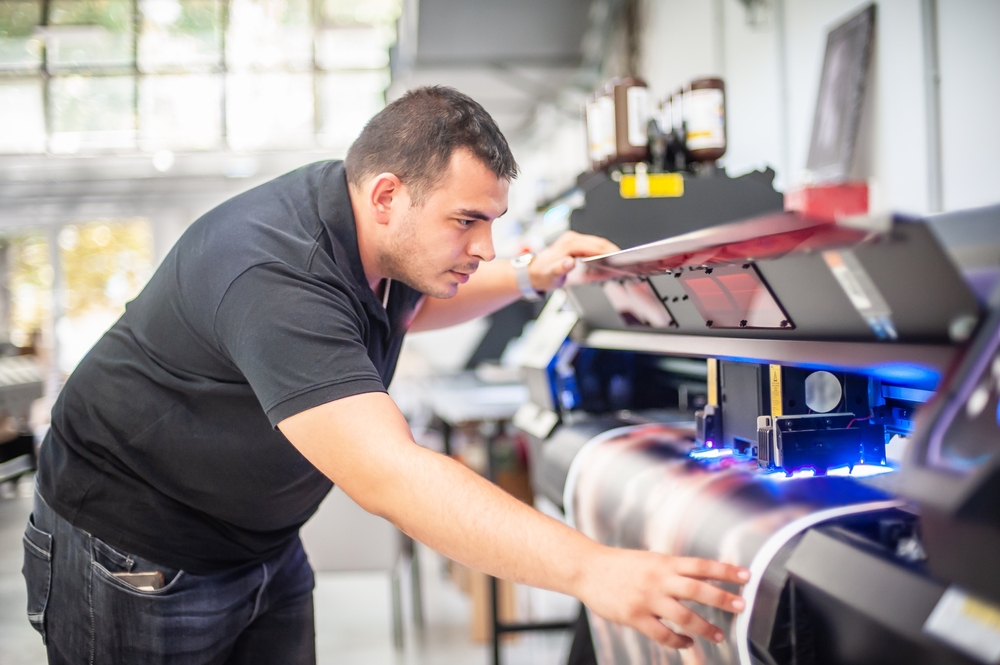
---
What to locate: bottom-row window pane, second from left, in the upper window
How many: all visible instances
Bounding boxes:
[50,76,135,152]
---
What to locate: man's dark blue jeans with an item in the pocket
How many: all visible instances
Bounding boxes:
[23,493,316,665]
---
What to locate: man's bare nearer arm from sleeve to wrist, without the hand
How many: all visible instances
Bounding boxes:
[281,393,592,594]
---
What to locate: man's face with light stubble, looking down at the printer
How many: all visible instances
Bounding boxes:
[379,149,509,298]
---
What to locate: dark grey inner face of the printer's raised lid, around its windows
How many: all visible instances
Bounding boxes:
[570,220,980,344]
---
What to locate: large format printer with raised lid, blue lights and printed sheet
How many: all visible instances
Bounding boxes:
[515,208,1000,665]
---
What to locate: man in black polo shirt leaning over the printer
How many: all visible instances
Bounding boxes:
[24,88,748,664]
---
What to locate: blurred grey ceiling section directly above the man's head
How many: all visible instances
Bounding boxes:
[386,0,600,137]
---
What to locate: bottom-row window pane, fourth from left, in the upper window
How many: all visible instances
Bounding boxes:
[226,73,314,150]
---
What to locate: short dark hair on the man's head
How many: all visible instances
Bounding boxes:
[344,86,517,204]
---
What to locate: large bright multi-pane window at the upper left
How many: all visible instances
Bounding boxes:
[0,0,401,154]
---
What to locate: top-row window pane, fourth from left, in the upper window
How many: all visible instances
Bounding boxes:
[226,0,313,71]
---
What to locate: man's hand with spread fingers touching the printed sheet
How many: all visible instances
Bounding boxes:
[578,548,750,649]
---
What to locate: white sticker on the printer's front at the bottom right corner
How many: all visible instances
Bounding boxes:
[924,586,1000,663]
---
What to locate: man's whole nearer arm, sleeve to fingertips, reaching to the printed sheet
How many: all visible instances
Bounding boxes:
[278,393,749,648]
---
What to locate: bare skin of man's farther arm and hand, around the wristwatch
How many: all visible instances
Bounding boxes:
[410,231,618,332]
